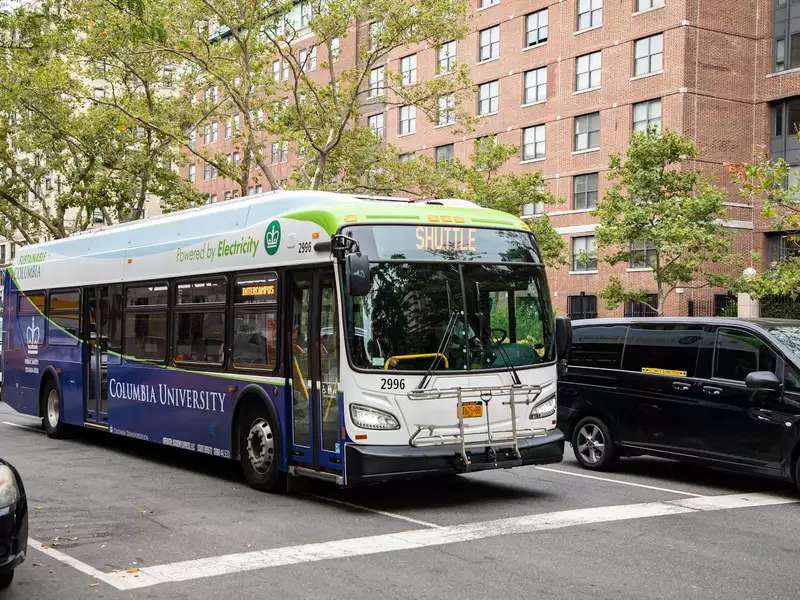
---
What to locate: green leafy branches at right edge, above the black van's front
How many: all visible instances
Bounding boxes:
[729,158,800,300]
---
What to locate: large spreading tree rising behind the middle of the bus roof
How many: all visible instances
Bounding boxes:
[95,0,471,194]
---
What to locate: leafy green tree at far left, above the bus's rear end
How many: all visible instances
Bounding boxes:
[0,2,197,242]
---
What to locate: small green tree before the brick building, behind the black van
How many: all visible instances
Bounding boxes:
[594,129,731,314]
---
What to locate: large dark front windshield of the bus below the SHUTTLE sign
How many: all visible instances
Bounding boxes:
[344,227,554,371]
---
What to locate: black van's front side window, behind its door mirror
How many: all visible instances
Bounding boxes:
[714,329,778,381]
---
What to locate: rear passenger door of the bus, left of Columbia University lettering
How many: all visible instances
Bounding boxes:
[83,285,122,427]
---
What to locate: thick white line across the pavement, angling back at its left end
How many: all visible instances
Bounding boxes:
[34,494,800,591]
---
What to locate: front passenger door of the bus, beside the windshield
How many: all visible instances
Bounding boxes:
[287,268,344,473]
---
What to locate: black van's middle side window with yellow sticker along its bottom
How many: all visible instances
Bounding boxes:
[622,324,703,377]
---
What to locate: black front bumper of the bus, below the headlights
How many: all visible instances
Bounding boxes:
[346,429,564,485]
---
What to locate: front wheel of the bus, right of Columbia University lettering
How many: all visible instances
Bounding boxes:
[239,402,286,493]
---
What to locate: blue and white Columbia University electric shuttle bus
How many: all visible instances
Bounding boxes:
[3,191,569,491]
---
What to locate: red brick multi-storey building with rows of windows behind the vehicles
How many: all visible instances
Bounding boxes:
[187,0,800,317]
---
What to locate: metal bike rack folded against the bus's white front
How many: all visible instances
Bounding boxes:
[408,384,547,471]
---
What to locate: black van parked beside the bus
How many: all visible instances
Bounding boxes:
[558,318,800,487]
